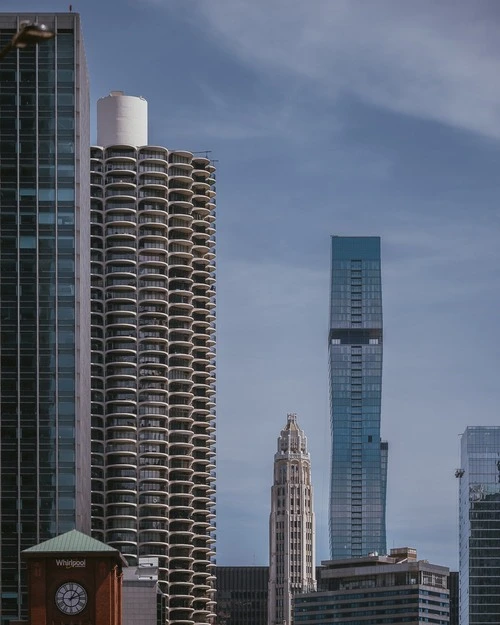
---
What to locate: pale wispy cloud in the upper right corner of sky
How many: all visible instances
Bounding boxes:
[179,0,500,138]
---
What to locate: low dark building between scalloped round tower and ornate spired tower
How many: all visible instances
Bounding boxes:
[216,566,269,625]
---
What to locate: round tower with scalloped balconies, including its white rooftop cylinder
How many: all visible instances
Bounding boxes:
[91,92,215,624]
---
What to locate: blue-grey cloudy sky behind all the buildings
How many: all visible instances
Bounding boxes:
[0,0,500,569]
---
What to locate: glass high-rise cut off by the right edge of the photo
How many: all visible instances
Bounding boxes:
[455,426,500,625]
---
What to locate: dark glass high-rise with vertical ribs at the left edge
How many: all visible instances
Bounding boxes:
[0,13,90,623]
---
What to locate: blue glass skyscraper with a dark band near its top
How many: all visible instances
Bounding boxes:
[328,236,388,560]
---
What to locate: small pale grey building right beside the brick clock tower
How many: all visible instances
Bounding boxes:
[122,558,164,625]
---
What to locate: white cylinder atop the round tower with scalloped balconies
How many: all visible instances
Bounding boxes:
[97,91,148,147]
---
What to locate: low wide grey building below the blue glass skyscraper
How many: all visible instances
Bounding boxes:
[294,548,449,625]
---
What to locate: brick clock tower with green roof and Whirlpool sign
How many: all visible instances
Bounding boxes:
[22,530,126,625]
